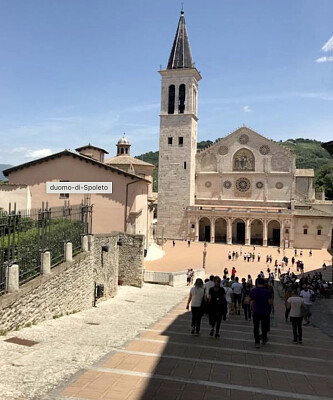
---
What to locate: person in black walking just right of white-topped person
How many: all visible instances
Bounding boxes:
[208,276,227,338]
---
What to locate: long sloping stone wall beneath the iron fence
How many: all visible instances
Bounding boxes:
[0,252,94,331]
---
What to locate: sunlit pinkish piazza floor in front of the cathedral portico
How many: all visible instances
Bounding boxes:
[145,241,332,277]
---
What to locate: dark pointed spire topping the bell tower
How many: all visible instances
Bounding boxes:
[167,7,193,69]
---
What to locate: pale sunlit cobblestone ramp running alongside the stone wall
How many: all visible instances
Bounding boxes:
[0,284,188,400]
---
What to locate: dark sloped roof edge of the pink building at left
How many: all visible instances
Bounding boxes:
[3,150,151,183]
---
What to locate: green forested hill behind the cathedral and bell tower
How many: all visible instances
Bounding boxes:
[137,138,333,199]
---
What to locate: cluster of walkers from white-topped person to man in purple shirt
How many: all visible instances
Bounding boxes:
[186,268,274,348]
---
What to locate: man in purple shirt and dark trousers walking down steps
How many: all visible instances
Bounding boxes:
[250,278,273,349]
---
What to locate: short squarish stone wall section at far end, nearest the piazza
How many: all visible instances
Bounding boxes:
[118,232,144,287]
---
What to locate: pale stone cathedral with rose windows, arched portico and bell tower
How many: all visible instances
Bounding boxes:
[157,12,333,248]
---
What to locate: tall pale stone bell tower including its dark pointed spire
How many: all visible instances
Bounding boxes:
[156,11,201,239]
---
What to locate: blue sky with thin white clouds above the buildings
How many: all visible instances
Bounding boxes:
[0,0,333,164]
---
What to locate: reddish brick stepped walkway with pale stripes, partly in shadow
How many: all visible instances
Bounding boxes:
[55,284,333,400]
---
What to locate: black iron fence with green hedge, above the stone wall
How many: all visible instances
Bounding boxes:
[0,203,92,294]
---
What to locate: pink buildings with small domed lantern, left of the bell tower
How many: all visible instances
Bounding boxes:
[0,138,154,248]
